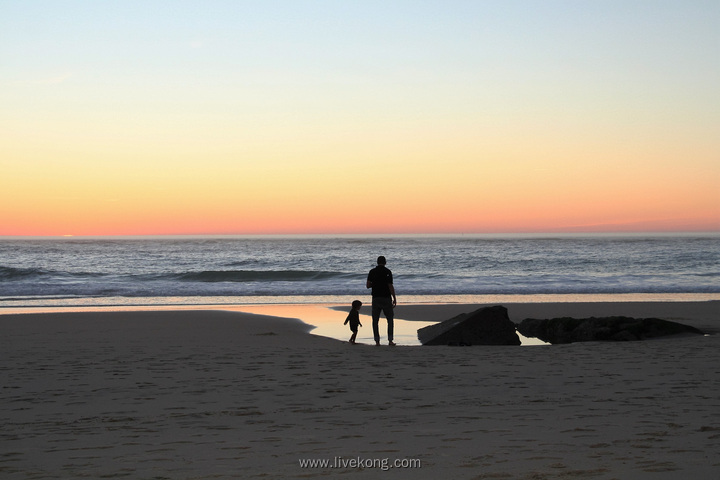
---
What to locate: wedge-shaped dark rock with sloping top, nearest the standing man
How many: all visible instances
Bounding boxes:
[418,306,520,346]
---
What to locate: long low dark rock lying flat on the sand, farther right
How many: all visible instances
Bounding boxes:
[518,317,703,343]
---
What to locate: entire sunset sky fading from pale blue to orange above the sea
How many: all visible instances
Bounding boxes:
[0,0,720,236]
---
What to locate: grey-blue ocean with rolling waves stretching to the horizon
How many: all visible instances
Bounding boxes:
[0,234,720,308]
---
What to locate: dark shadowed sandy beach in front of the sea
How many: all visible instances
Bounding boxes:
[0,301,720,479]
